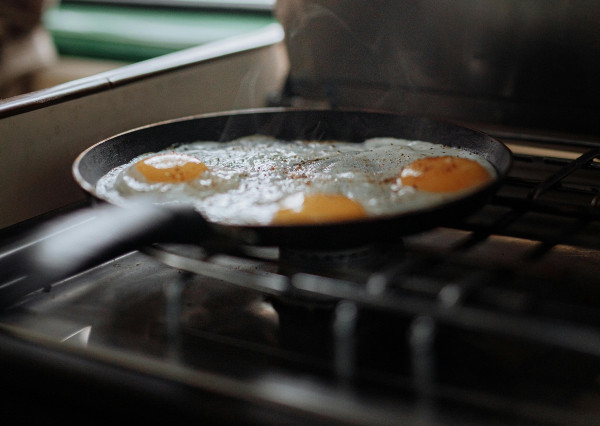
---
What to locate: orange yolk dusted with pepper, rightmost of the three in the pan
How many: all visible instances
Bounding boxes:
[400,156,491,192]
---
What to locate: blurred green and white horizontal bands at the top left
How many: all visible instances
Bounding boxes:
[44,0,275,62]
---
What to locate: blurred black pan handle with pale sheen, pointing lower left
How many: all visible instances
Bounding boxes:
[0,204,213,307]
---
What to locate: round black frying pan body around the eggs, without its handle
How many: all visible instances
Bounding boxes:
[73,109,511,248]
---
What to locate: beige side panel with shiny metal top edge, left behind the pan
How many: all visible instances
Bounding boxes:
[0,24,288,228]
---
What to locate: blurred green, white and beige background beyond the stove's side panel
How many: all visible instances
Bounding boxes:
[0,0,275,98]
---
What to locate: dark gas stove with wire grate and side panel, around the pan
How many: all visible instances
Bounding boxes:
[0,0,600,425]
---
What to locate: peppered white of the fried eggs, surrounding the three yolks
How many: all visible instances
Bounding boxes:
[96,135,496,225]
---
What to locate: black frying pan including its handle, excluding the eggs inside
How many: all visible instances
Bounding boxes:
[8,108,511,302]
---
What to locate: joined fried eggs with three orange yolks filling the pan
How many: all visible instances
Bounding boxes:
[96,135,496,225]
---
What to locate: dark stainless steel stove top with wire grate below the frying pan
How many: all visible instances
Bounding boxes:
[0,125,600,425]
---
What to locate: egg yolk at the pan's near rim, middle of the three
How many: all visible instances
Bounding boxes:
[273,194,367,224]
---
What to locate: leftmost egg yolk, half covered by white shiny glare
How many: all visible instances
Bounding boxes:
[136,153,208,183]
